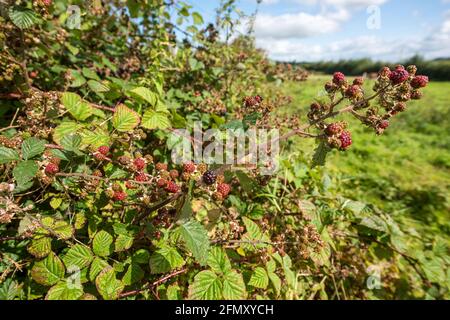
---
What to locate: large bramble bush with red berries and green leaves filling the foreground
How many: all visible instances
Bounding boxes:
[0,0,450,300]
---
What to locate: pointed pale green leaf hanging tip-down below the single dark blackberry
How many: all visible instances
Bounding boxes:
[180,220,209,265]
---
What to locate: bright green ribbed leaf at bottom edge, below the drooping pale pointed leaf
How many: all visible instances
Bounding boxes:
[188,270,222,300]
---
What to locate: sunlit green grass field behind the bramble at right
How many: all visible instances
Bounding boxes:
[279,76,450,239]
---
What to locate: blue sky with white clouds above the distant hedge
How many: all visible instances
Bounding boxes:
[186,0,450,62]
